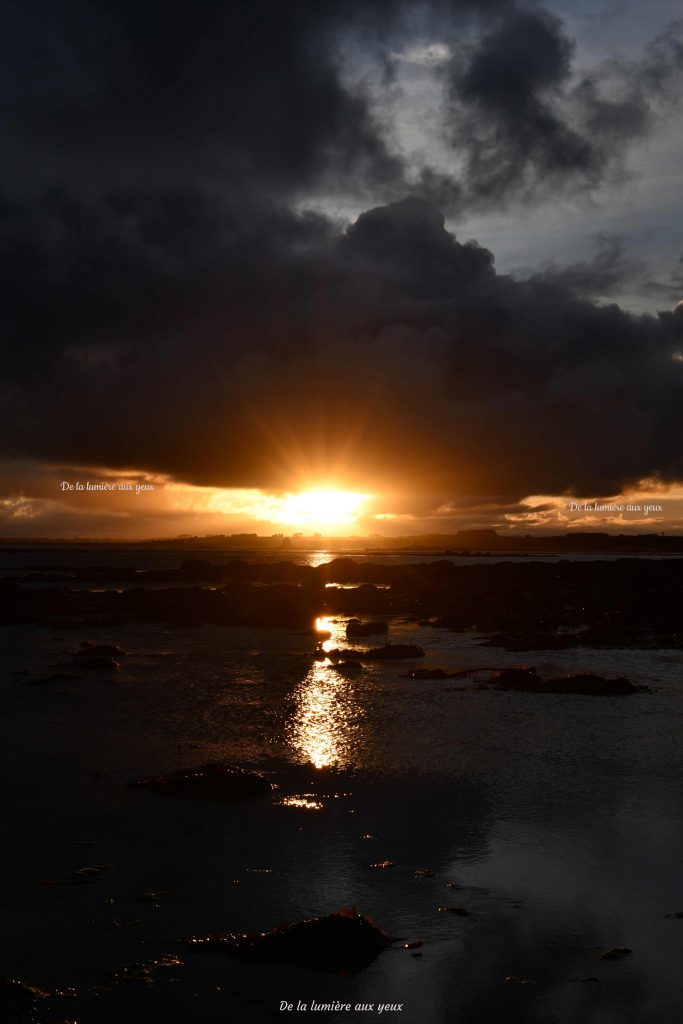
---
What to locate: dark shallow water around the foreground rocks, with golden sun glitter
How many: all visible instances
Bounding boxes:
[0,558,683,1024]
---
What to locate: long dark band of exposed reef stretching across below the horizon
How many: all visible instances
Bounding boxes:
[0,558,683,656]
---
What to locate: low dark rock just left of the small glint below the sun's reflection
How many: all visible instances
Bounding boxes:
[133,761,271,802]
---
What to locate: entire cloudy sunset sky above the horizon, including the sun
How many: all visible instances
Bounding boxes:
[0,0,683,539]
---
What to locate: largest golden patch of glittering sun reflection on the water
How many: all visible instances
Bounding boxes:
[287,664,362,768]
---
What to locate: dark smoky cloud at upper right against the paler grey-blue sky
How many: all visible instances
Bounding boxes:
[440,4,683,209]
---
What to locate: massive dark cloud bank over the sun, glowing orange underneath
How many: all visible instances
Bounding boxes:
[0,0,683,500]
